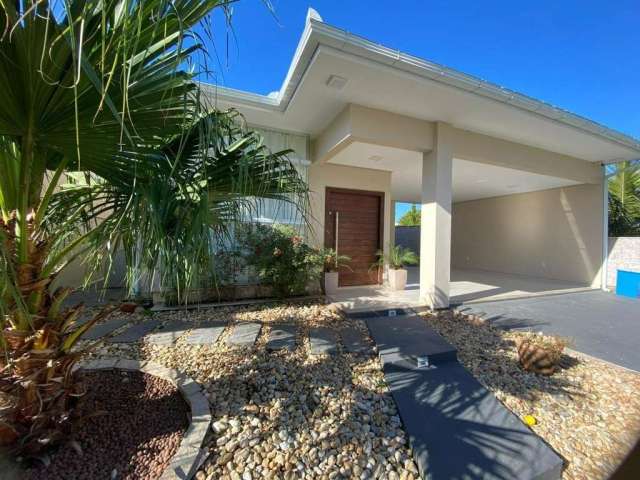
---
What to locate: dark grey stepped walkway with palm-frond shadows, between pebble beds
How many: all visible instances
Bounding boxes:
[361,313,562,480]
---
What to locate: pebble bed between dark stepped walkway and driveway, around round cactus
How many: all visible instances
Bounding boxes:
[424,312,640,480]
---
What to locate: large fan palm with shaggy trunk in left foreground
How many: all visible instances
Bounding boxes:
[0,0,306,454]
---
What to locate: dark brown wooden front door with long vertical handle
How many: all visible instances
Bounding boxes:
[324,187,384,287]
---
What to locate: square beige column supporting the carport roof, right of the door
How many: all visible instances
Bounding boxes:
[420,123,453,309]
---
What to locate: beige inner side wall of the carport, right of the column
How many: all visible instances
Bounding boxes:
[451,184,603,287]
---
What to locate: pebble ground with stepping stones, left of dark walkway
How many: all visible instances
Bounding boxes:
[89,304,418,480]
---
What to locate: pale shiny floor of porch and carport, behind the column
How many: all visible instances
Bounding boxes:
[331,267,589,311]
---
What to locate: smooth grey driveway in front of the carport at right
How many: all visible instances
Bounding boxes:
[457,290,640,371]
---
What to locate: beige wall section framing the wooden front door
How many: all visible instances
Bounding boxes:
[308,163,391,258]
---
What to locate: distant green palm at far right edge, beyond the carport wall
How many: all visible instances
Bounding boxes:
[609,162,640,236]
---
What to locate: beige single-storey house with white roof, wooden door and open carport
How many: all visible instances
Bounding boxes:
[205,9,640,308]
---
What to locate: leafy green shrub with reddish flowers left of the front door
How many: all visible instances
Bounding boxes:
[242,224,324,297]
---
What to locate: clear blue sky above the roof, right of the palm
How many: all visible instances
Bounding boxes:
[208,0,640,218]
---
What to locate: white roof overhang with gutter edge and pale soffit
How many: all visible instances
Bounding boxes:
[205,7,640,163]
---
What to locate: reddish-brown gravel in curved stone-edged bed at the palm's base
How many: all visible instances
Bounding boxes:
[26,370,190,480]
